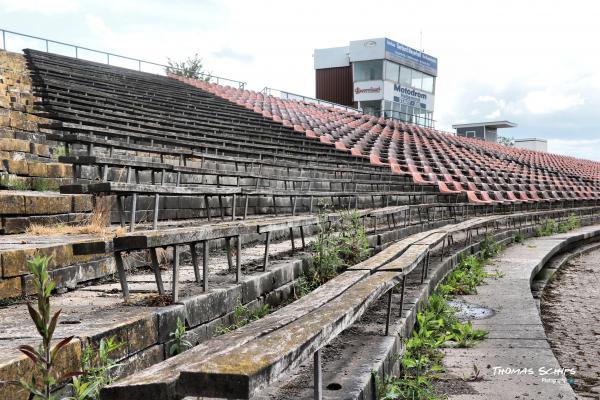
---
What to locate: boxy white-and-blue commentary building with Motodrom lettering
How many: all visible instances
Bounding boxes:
[314,38,438,127]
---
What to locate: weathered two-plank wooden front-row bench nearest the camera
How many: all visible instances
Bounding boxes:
[101,227,440,400]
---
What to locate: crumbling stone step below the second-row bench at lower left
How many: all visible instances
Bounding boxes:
[0,256,307,400]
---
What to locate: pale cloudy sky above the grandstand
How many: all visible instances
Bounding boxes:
[0,0,600,161]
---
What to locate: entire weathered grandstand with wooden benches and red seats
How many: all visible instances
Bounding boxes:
[0,33,600,399]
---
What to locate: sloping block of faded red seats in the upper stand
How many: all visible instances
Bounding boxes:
[178,78,600,206]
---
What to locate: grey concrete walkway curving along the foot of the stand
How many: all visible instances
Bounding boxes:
[444,225,600,400]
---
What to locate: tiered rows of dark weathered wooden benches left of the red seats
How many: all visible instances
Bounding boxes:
[26,50,466,230]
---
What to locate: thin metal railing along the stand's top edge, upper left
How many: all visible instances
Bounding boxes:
[0,28,246,89]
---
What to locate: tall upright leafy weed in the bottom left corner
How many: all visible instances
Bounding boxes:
[0,255,82,399]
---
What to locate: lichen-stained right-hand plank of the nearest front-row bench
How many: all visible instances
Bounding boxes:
[176,271,402,398]
